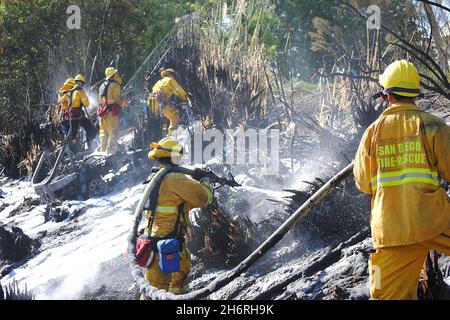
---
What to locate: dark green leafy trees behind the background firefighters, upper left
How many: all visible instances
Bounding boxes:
[0,0,193,133]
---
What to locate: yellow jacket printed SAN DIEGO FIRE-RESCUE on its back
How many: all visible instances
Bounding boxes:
[353,103,450,248]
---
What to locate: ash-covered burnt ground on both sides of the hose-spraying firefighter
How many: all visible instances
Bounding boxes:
[0,118,450,300]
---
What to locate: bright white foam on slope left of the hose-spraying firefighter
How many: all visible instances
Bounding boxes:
[0,178,144,299]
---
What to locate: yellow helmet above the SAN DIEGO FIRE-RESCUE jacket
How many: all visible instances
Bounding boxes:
[374,60,421,98]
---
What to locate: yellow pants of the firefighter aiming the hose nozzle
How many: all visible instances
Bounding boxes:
[141,245,191,300]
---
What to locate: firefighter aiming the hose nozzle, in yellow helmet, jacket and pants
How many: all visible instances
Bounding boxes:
[141,137,213,300]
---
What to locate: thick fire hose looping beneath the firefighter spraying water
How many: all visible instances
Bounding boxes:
[128,162,353,300]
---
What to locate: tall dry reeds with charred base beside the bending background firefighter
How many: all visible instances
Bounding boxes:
[126,1,269,129]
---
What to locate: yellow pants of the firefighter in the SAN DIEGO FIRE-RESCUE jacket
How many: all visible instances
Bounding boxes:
[369,229,450,300]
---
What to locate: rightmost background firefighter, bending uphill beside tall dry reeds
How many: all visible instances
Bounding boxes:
[147,69,187,135]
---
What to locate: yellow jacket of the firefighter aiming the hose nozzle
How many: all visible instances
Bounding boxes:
[146,172,213,237]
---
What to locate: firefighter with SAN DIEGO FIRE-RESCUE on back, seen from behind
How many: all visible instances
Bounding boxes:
[354,60,450,300]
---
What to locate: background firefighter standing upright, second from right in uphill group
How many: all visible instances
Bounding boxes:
[97,67,128,153]
